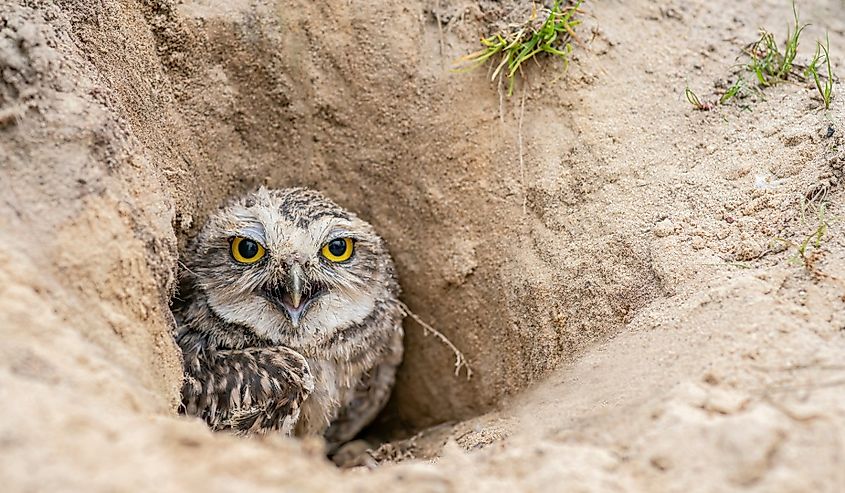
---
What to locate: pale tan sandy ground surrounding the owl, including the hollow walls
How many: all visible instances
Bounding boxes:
[0,0,845,492]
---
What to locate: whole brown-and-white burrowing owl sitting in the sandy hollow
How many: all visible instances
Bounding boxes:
[174,188,404,447]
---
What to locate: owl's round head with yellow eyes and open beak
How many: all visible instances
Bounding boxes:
[187,188,399,348]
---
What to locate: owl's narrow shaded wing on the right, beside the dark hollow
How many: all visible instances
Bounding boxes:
[324,328,402,452]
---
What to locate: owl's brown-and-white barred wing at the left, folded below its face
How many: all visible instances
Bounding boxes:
[181,347,314,435]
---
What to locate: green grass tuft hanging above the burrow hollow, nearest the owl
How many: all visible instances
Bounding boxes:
[458,0,581,96]
